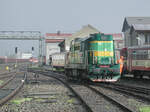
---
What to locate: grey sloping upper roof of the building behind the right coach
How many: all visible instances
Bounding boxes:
[122,17,150,32]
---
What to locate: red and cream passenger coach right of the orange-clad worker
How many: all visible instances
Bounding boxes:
[121,45,150,78]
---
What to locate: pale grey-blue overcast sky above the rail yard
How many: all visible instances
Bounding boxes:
[0,0,150,55]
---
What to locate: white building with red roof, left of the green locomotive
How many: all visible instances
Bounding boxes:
[45,31,72,65]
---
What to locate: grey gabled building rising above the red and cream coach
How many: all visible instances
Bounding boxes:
[122,17,150,47]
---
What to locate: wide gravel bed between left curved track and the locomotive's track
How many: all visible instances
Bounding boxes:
[0,73,84,112]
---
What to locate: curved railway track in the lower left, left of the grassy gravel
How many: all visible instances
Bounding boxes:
[0,72,26,106]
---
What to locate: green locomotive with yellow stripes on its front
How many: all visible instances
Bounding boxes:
[65,33,121,82]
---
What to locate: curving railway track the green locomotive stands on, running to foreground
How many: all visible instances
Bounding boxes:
[29,71,135,112]
